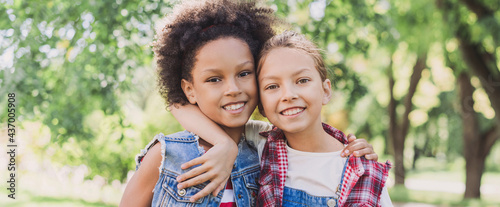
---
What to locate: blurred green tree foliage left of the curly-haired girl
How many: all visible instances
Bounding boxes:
[0,0,179,180]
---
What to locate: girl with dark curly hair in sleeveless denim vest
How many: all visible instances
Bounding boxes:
[120,0,278,206]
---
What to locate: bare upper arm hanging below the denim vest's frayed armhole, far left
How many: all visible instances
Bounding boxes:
[120,143,162,207]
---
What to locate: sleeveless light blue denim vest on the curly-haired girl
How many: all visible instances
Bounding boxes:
[136,131,260,207]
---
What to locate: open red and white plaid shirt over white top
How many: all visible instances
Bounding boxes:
[257,123,391,207]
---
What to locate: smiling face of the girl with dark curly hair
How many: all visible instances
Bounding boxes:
[182,37,258,128]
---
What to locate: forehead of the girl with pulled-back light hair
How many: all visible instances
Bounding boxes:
[259,47,316,76]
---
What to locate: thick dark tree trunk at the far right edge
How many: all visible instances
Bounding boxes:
[436,0,500,198]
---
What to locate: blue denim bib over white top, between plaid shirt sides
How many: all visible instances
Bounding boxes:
[283,186,337,207]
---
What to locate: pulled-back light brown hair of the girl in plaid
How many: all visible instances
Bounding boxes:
[257,31,327,81]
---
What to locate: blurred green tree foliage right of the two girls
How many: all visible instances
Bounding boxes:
[271,0,500,180]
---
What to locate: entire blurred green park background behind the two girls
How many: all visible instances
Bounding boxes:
[0,0,500,206]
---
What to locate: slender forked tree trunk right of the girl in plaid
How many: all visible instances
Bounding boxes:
[389,53,427,185]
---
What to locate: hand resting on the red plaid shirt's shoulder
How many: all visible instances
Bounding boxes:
[340,134,378,161]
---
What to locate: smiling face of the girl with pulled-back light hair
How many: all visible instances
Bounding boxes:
[259,47,332,133]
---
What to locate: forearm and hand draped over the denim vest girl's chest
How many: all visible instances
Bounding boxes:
[170,104,238,202]
